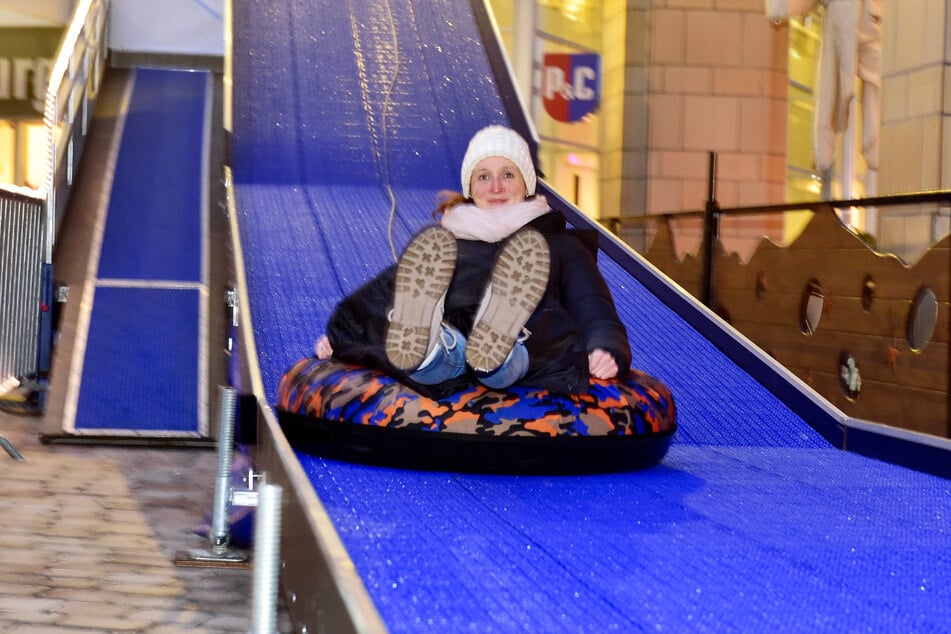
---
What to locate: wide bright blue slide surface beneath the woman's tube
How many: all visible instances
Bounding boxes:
[232,0,951,632]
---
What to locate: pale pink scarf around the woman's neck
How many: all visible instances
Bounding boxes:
[441,196,549,242]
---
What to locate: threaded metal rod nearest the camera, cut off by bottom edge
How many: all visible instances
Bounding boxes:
[251,484,283,634]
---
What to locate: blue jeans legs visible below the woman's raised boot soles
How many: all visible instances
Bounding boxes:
[410,322,528,389]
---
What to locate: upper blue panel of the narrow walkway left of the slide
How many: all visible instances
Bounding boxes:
[98,68,210,282]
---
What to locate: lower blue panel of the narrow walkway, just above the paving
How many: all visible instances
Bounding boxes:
[75,287,200,432]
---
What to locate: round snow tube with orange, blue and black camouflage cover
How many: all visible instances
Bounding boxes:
[276,357,677,473]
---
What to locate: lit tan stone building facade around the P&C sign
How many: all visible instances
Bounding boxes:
[491,0,951,260]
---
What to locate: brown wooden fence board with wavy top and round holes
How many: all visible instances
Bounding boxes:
[646,206,951,437]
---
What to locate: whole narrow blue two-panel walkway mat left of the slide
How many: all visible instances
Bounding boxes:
[69,68,211,436]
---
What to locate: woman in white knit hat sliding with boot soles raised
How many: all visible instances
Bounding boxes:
[317,126,631,398]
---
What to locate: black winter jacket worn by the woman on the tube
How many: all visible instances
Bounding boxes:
[327,211,631,398]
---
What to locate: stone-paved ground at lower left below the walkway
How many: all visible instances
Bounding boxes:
[0,412,292,634]
